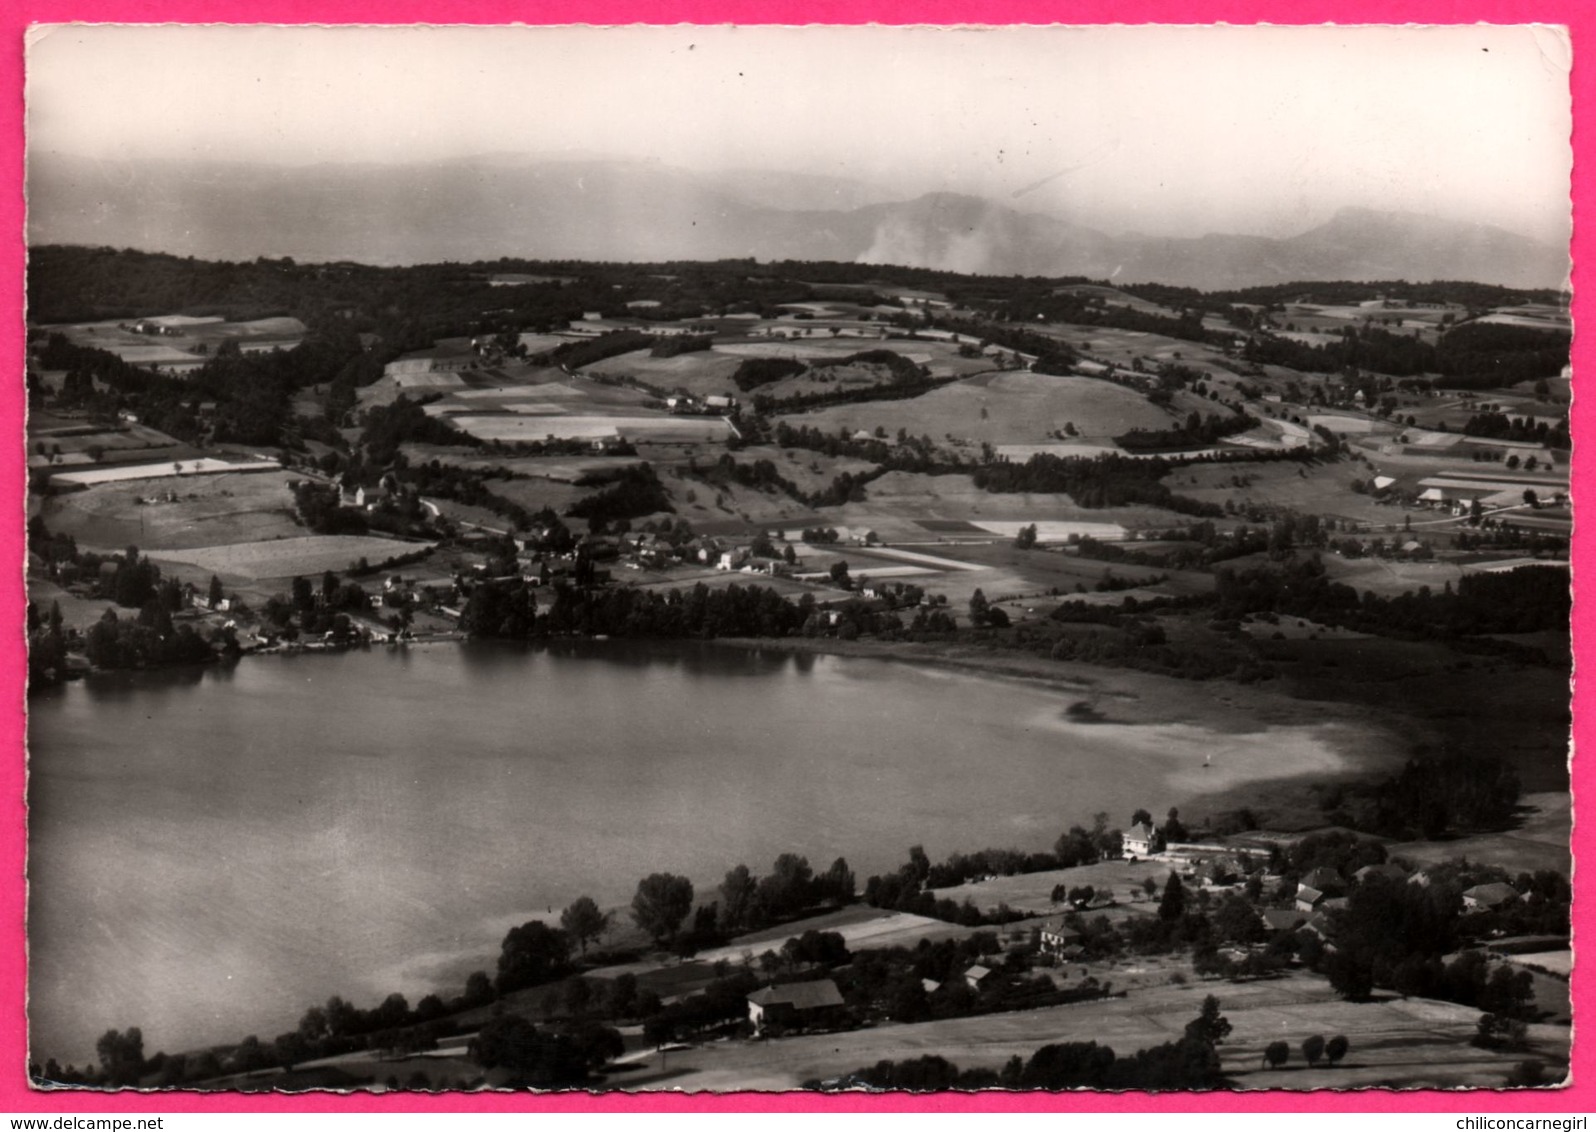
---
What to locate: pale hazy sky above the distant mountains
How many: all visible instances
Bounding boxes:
[27,26,1572,239]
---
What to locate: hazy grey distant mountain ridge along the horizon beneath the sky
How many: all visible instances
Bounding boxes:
[27,153,1569,291]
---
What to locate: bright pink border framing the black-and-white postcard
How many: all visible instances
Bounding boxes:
[0,0,1596,1114]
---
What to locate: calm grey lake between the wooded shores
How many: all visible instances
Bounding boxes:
[29,642,1355,1065]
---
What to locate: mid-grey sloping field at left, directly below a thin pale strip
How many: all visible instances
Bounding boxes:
[41,471,303,551]
